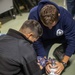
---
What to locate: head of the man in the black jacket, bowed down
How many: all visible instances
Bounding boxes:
[19,20,43,42]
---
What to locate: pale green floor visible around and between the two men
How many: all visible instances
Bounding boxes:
[1,0,75,75]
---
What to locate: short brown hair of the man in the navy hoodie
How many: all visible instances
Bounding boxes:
[40,4,58,24]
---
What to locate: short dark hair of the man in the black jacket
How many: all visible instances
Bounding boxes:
[21,19,43,38]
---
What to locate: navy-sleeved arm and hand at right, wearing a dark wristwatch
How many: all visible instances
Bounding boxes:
[56,9,75,74]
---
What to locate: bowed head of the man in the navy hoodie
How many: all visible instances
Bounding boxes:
[40,4,60,29]
